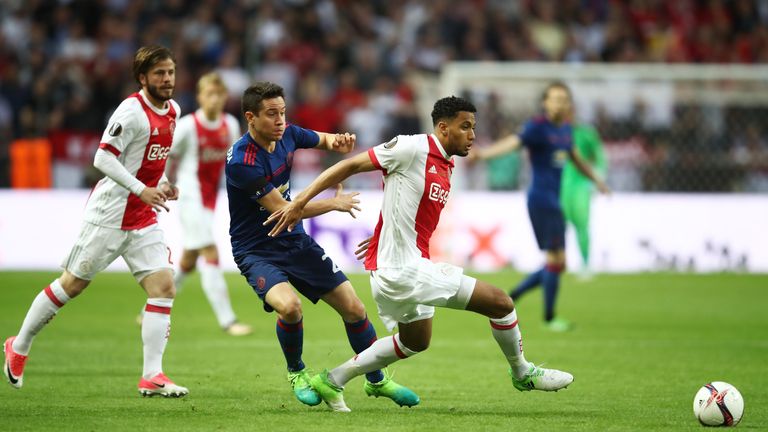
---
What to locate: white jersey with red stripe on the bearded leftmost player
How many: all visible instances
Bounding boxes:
[85,90,179,230]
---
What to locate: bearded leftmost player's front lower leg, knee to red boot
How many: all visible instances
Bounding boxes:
[139,269,189,397]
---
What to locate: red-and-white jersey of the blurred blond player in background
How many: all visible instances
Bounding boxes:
[171,109,241,210]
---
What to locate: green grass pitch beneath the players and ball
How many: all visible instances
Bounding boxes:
[0,272,768,431]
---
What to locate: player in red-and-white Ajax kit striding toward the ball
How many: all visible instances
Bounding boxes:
[267,97,573,411]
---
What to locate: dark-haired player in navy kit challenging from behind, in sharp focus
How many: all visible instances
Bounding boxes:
[225,82,419,406]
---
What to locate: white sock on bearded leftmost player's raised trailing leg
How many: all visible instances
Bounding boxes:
[13,279,69,355]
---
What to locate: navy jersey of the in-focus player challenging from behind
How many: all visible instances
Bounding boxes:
[224,125,320,257]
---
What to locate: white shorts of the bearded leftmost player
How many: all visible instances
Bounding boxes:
[61,222,173,282]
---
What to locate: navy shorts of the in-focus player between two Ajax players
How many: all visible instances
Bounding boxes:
[235,234,348,312]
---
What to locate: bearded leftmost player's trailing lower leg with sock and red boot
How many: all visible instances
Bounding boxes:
[3,270,90,388]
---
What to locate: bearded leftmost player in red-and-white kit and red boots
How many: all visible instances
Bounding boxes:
[3,46,188,397]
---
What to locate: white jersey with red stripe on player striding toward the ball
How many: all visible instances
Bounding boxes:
[365,134,453,270]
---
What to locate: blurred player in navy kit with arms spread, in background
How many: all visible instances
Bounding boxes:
[473,82,609,331]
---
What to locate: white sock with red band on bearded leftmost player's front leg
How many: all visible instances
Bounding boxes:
[141,298,173,379]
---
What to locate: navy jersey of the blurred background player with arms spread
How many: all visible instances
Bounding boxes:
[520,116,573,208]
